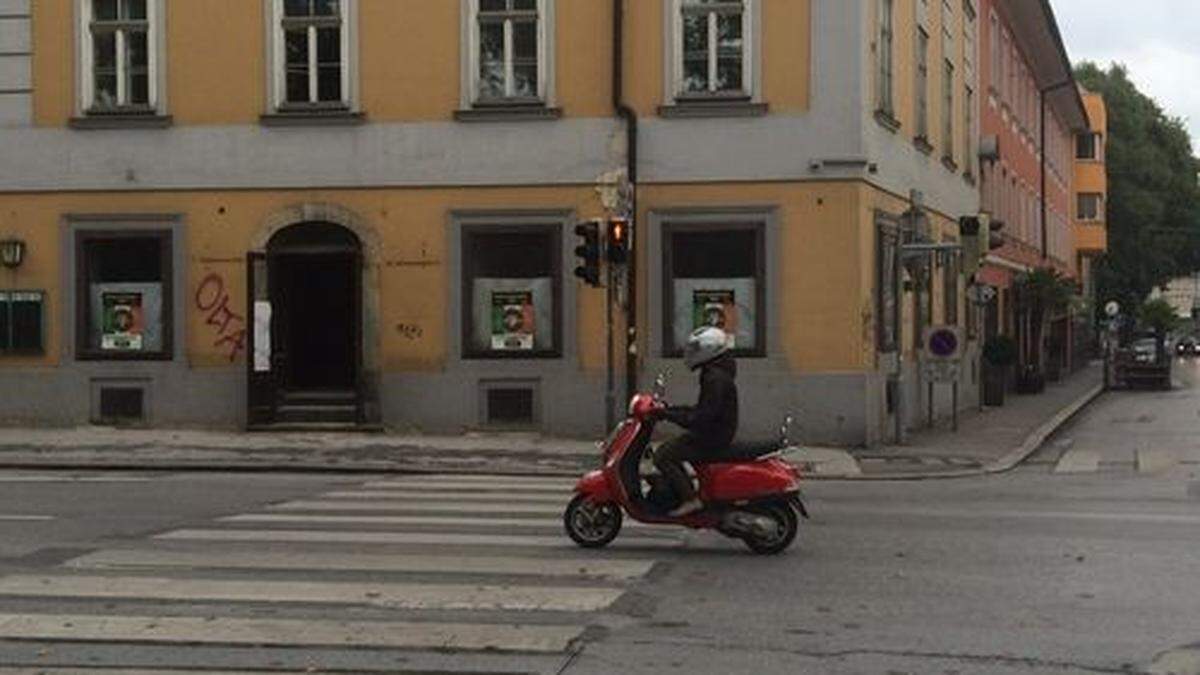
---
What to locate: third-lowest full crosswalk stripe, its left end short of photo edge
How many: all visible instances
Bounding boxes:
[66,549,655,581]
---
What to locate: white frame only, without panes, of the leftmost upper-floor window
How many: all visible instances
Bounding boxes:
[74,0,167,115]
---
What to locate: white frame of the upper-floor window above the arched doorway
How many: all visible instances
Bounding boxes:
[264,0,359,113]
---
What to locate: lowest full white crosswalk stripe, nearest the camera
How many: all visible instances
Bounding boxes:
[0,614,583,653]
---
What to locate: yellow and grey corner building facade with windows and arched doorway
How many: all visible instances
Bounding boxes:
[0,0,978,444]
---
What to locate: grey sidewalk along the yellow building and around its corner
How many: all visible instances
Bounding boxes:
[0,366,1100,479]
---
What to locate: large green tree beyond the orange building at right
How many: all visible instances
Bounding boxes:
[1075,62,1200,307]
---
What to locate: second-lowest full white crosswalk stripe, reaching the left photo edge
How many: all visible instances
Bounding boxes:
[0,575,624,611]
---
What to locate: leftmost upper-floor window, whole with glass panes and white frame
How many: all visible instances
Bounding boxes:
[79,0,162,114]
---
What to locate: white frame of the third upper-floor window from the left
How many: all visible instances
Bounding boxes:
[461,0,556,108]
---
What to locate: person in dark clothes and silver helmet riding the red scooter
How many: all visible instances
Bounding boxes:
[654,327,738,518]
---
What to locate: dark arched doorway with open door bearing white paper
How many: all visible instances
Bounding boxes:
[250,221,362,425]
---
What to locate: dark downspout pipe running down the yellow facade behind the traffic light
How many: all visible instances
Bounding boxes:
[612,0,641,400]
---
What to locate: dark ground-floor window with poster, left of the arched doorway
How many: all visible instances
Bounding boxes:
[76,231,174,360]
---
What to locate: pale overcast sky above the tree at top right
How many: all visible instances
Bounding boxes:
[1051,0,1200,148]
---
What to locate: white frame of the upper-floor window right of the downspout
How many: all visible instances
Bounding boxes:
[664,0,762,103]
